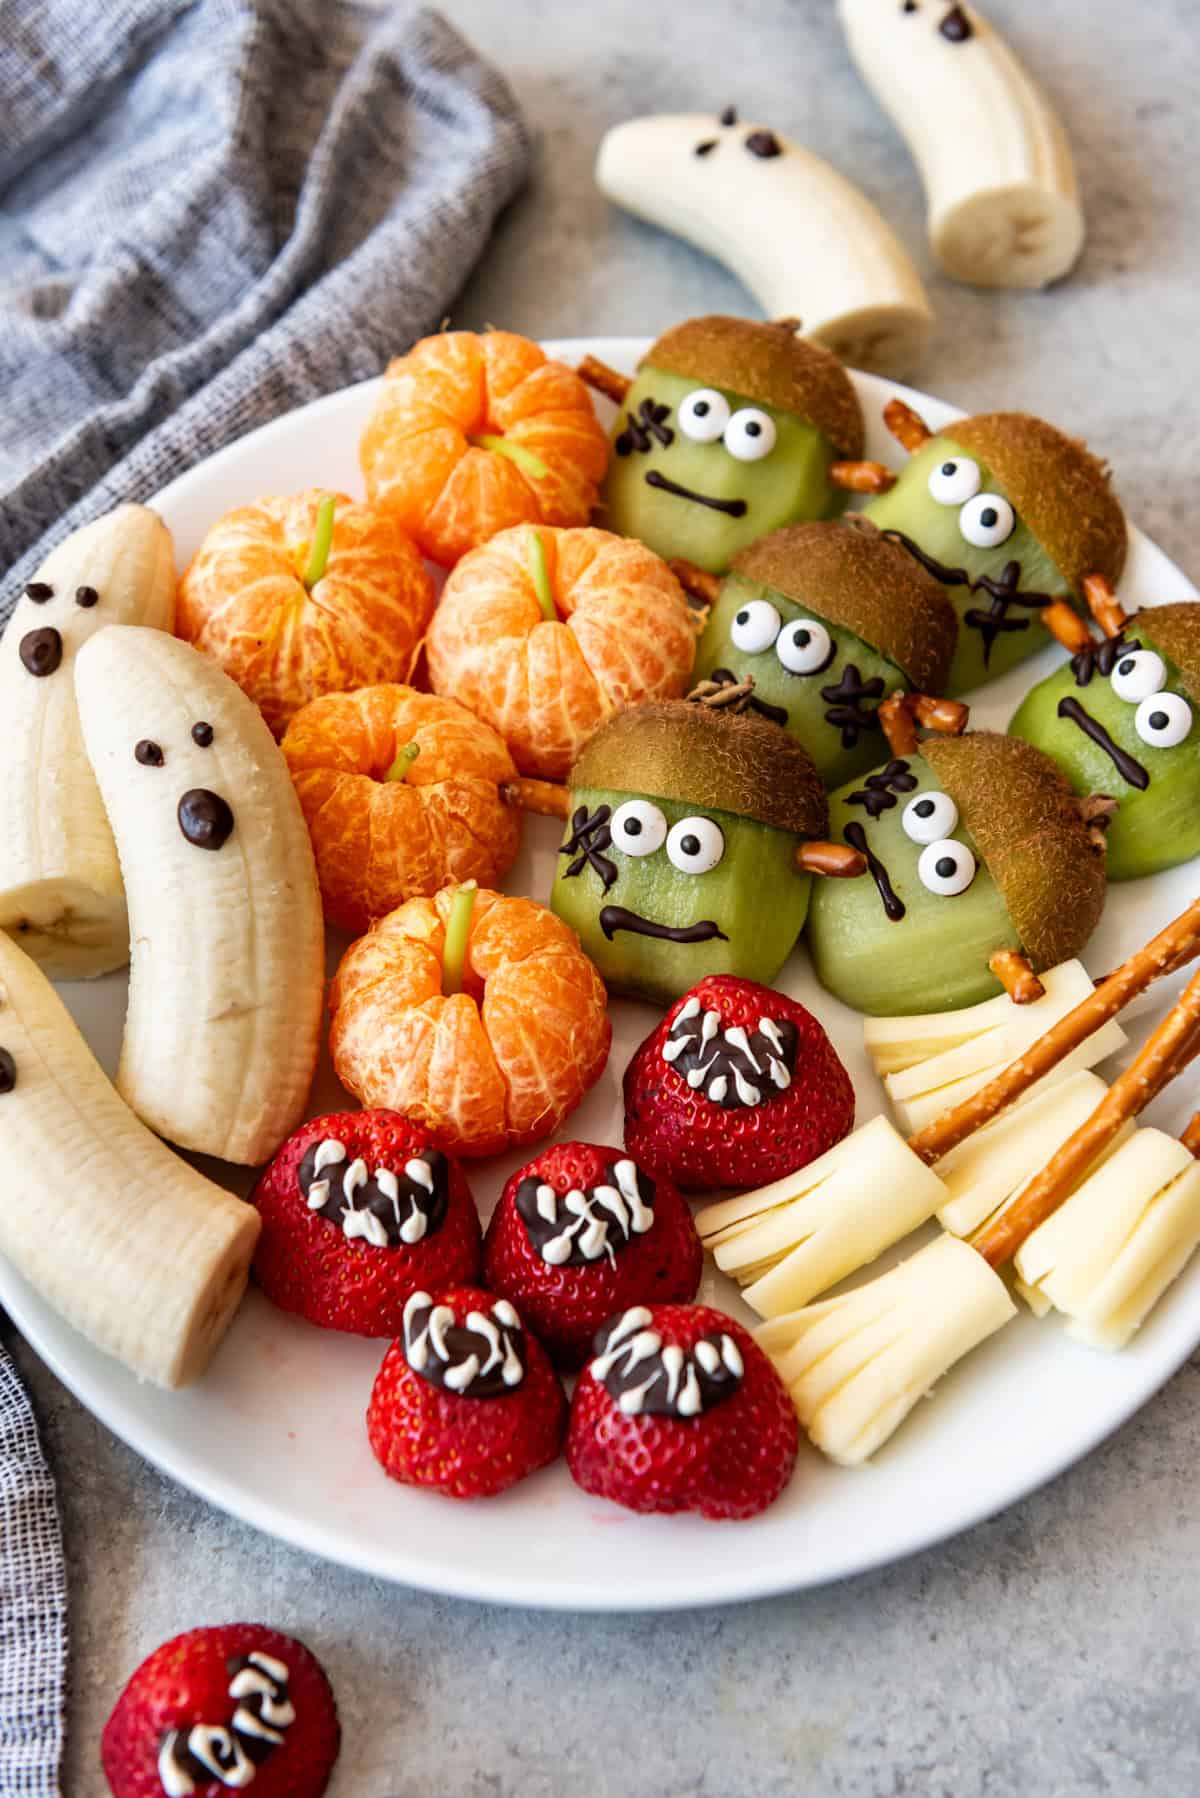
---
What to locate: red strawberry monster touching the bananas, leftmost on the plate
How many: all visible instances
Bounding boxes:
[250,1111,482,1336]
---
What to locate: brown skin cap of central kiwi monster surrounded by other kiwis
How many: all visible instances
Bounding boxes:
[734,521,959,694]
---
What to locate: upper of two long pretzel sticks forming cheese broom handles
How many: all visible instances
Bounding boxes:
[909,899,1200,1165]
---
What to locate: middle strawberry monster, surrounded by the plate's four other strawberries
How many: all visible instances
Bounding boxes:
[484,1142,703,1368]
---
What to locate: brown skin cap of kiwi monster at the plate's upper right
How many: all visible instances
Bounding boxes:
[939,412,1126,593]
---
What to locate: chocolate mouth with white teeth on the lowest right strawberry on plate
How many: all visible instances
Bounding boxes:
[590,1305,745,1422]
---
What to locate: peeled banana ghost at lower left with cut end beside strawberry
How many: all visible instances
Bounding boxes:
[0,935,259,1386]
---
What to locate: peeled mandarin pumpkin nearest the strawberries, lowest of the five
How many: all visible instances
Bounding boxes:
[329,888,612,1156]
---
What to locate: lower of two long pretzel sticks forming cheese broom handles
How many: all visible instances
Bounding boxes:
[973,973,1200,1268]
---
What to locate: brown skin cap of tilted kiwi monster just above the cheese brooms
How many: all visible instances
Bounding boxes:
[921,730,1105,973]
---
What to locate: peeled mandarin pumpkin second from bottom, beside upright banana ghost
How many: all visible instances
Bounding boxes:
[281,685,522,933]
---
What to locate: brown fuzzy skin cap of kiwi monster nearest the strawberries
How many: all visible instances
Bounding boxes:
[569,699,829,840]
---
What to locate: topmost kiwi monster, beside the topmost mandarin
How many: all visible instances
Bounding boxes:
[583,316,864,574]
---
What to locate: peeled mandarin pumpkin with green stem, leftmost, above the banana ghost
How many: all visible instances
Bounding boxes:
[175,487,434,735]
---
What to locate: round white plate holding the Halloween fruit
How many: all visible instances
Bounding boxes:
[0,338,1200,1611]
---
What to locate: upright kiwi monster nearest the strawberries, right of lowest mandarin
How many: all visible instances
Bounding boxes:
[551,701,864,1003]
